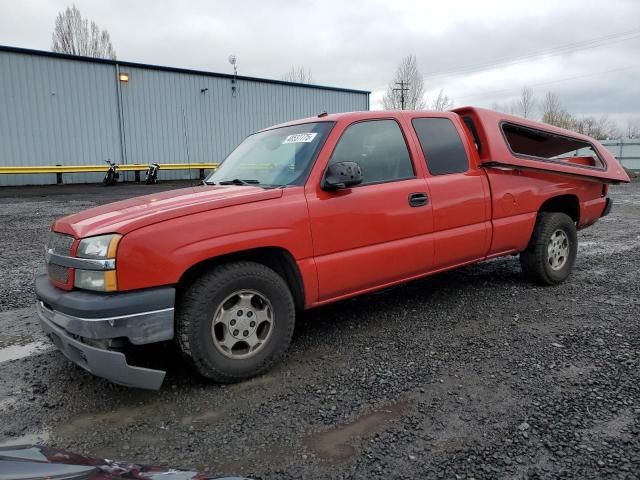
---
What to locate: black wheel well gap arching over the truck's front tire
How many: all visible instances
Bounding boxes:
[178,247,304,310]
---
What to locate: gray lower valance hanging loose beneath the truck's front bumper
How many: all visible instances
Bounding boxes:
[38,309,165,390]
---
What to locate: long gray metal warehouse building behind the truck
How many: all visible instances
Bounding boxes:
[0,46,369,185]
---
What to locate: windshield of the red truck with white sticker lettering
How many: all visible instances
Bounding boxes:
[206,122,333,186]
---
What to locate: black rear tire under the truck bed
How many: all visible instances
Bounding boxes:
[520,212,578,285]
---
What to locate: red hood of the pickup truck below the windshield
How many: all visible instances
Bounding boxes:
[53,185,282,238]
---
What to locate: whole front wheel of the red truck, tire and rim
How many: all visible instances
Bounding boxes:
[176,262,295,383]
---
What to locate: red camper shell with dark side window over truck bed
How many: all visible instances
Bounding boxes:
[453,107,630,183]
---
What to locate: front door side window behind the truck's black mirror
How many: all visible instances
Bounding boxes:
[329,120,415,184]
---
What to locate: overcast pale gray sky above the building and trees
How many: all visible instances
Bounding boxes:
[0,0,640,124]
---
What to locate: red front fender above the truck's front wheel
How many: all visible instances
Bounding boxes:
[117,191,313,290]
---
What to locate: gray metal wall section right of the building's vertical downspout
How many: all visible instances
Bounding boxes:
[122,68,366,178]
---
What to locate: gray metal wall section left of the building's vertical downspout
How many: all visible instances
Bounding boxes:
[0,52,122,185]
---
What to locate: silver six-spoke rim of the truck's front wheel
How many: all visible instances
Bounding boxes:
[211,290,275,359]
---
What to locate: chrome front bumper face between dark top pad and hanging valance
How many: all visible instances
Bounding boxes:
[36,301,174,345]
